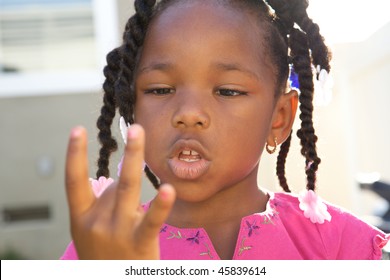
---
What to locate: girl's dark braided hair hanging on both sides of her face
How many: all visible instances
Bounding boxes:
[96,0,331,192]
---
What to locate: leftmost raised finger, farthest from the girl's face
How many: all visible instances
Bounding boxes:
[65,127,95,217]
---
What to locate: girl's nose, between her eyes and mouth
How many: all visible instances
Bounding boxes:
[172,88,210,129]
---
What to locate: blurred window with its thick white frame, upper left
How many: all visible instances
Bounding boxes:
[0,0,118,97]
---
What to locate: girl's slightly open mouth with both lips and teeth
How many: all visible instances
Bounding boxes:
[168,140,210,180]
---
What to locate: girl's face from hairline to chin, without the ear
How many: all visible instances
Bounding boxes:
[135,1,288,202]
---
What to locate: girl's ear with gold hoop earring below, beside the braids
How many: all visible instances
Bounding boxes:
[267,90,298,146]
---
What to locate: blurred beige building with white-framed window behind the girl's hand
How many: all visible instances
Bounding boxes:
[0,0,139,259]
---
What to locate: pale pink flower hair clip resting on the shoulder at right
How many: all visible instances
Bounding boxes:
[298,190,332,224]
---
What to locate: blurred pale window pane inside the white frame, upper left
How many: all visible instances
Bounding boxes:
[0,0,98,72]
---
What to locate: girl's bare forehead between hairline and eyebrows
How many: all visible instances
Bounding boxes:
[141,1,272,83]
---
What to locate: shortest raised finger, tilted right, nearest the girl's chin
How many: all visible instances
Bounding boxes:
[138,184,176,246]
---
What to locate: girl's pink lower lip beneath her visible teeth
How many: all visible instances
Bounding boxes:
[168,158,210,180]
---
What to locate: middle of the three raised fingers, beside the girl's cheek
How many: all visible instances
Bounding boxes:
[115,124,145,215]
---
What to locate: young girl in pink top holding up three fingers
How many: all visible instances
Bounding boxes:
[62,0,389,260]
